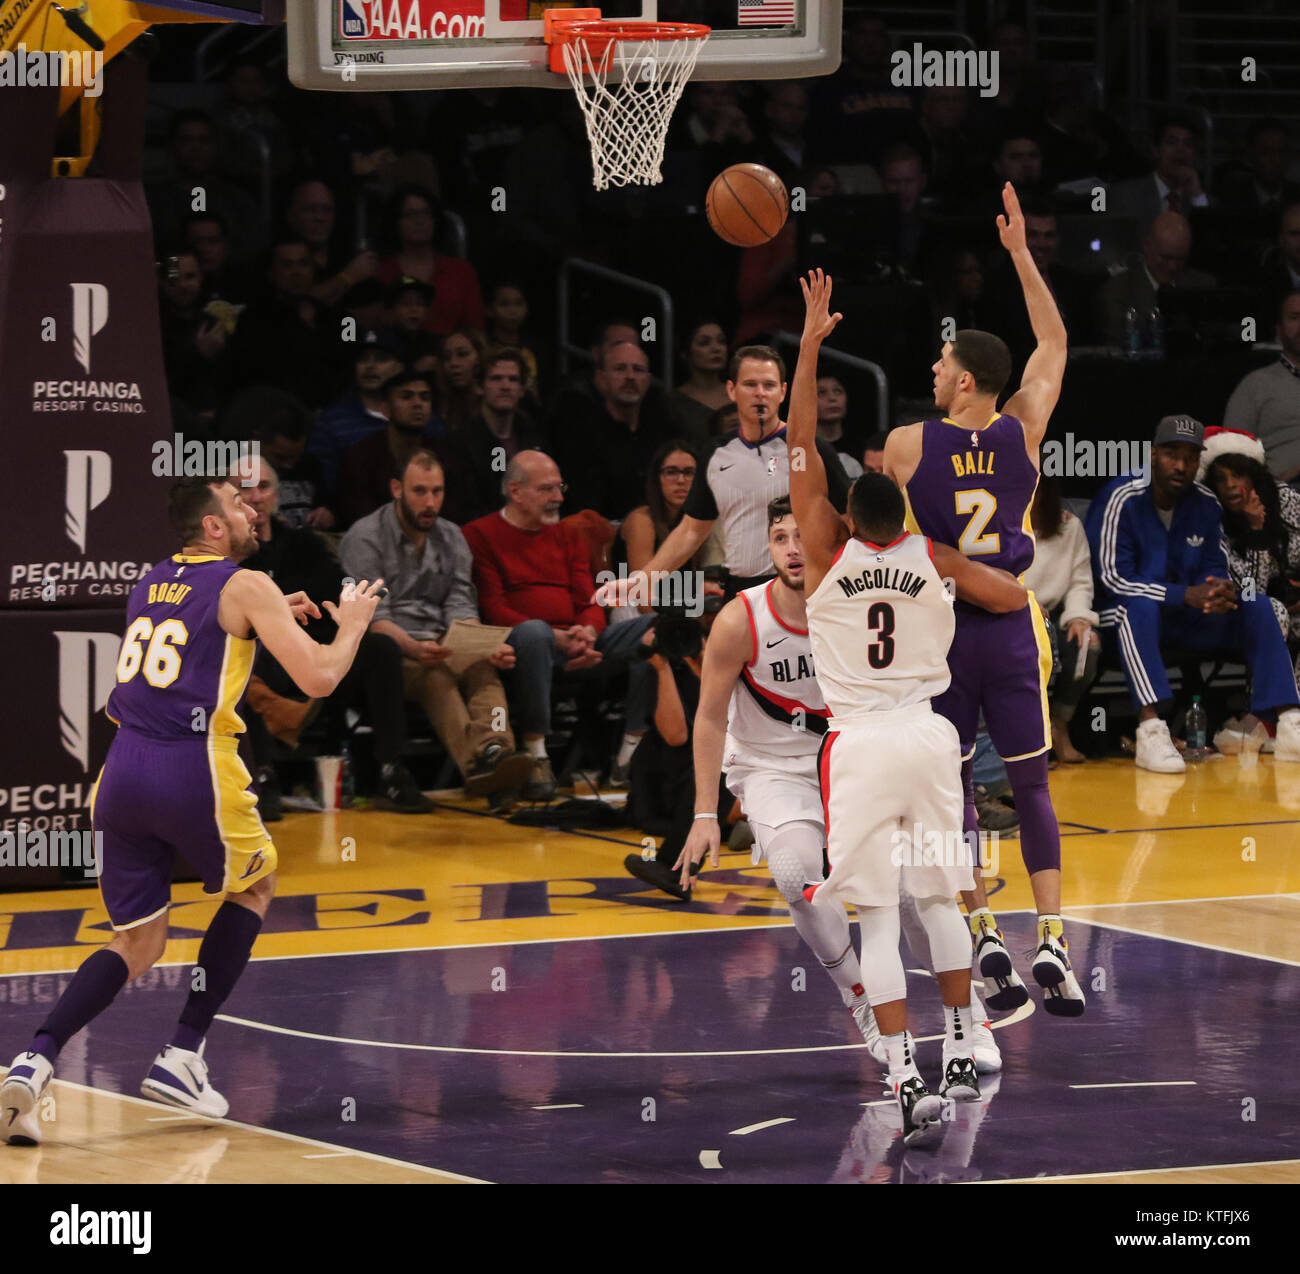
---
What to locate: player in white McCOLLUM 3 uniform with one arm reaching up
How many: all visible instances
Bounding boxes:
[787,270,1028,1144]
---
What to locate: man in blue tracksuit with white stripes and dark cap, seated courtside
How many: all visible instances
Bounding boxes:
[1087,416,1300,774]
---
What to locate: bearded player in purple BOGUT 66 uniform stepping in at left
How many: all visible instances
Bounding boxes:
[0,478,384,1145]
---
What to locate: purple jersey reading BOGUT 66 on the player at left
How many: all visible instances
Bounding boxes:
[108,554,257,740]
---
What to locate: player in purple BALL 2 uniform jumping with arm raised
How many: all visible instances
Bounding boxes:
[885,182,1086,1017]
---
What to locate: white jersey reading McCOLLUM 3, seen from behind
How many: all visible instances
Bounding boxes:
[807,534,956,728]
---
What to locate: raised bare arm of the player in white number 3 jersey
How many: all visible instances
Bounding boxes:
[785,270,849,590]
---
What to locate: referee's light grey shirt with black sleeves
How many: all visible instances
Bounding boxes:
[683,425,850,579]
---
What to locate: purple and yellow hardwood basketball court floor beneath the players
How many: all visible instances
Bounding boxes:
[0,758,1300,1182]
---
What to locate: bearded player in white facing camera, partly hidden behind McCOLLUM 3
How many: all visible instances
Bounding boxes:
[676,497,1002,1075]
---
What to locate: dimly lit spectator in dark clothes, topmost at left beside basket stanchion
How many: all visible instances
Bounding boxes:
[148,111,265,259]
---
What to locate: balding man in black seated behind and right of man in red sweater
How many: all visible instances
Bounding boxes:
[553,342,673,520]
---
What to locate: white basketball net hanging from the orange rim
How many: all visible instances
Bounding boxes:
[564,35,705,190]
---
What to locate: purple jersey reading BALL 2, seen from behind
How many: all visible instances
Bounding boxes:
[904,415,1039,577]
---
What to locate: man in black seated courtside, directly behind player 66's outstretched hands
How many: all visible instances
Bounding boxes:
[242,459,433,814]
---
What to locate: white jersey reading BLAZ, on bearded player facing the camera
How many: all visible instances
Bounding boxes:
[724,580,829,759]
